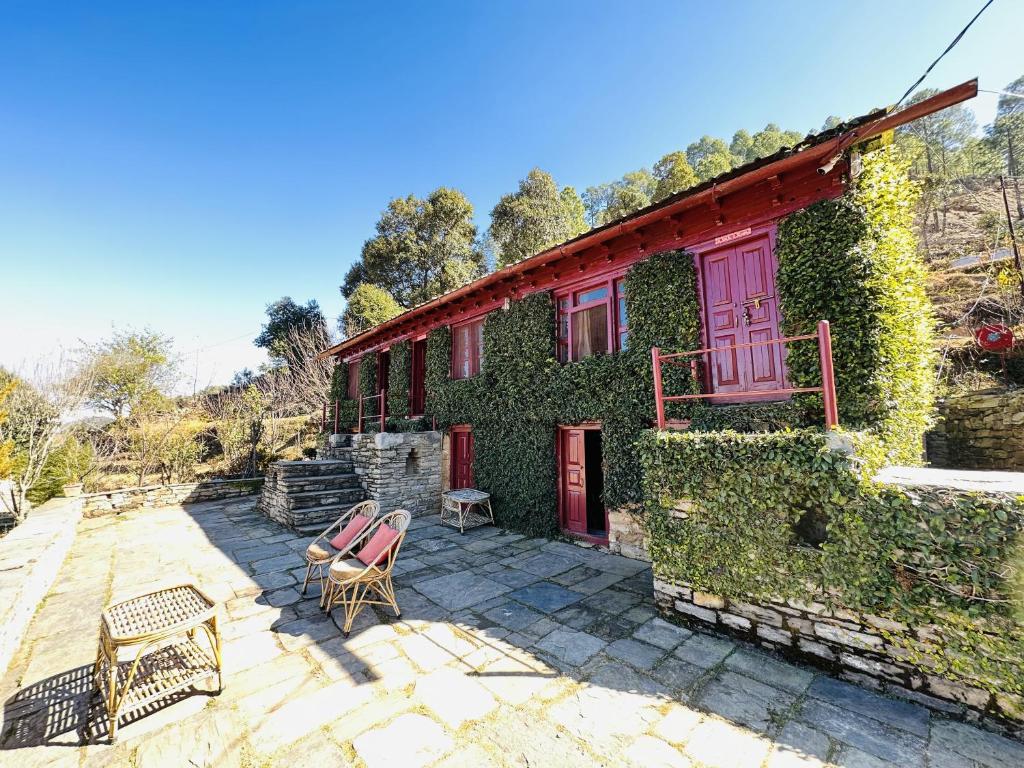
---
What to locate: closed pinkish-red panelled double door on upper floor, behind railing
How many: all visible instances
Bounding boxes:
[702,237,785,392]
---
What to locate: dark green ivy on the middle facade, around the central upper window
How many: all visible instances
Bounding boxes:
[419,251,699,535]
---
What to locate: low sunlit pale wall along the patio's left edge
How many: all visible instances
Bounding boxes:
[0,499,84,676]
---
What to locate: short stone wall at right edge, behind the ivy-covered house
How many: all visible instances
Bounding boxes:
[926,389,1024,470]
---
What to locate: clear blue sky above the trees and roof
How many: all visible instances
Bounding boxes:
[0,0,1024,387]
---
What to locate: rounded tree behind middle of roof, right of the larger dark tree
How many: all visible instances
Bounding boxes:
[487,168,587,267]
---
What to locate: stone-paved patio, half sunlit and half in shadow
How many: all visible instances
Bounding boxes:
[0,500,1024,768]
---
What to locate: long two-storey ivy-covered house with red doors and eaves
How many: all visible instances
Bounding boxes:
[325,81,977,549]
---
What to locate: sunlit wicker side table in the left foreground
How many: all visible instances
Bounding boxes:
[93,584,223,741]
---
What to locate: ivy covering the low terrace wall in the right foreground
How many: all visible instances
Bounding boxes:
[638,429,1024,693]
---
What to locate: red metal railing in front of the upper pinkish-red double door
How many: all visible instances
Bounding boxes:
[650,321,839,429]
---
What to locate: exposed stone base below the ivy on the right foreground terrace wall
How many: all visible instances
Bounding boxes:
[654,578,1024,738]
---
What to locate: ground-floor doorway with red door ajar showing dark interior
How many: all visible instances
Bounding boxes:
[558,425,608,543]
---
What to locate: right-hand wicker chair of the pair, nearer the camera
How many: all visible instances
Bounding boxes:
[326,509,413,637]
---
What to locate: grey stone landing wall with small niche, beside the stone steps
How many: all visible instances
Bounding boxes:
[352,432,441,515]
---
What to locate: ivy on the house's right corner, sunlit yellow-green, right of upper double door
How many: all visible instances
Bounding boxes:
[776,145,935,464]
